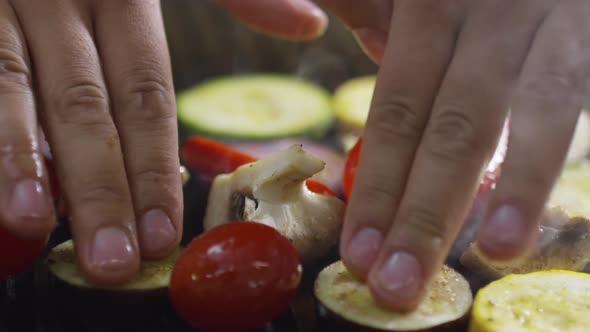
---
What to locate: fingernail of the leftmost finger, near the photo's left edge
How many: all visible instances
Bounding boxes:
[8,179,51,219]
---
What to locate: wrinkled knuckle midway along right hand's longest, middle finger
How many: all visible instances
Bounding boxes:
[424,108,485,161]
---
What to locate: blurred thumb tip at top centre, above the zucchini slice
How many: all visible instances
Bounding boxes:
[214,0,328,40]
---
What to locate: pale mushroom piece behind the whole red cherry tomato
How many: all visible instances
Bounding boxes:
[204,145,345,262]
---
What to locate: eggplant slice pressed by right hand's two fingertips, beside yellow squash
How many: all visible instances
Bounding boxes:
[314,261,473,332]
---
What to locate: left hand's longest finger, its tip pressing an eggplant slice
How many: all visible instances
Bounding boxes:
[16,1,139,284]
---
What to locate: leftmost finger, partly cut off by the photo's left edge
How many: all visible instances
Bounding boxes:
[0,0,55,238]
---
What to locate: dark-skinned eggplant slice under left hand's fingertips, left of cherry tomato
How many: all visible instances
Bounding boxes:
[47,240,180,326]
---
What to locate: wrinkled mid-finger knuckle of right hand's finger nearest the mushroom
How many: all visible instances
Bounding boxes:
[372,95,423,143]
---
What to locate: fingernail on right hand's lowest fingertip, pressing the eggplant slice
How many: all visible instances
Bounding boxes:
[376,251,422,301]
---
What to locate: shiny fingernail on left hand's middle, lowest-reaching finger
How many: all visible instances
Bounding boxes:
[90,227,135,271]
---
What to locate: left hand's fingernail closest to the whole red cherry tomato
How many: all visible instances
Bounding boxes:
[138,210,177,253]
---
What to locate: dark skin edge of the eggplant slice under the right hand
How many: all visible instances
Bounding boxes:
[314,299,470,332]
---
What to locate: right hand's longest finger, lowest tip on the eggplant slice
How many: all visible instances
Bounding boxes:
[369,2,556,310]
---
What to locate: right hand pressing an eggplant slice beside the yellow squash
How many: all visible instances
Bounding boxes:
[220,0,590,310]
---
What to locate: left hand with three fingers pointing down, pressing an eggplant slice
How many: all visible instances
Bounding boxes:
[0,0,182,284]
